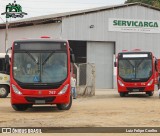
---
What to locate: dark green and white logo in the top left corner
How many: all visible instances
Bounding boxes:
[1,1,27,18]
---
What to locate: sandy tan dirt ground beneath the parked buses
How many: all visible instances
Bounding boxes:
[0,90,160,135]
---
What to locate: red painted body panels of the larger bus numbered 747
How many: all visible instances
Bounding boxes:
[10,37,71,104]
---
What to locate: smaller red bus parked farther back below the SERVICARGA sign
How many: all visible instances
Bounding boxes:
[116,51,156,97]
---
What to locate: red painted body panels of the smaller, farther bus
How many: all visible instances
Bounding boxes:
[116,50,157,94]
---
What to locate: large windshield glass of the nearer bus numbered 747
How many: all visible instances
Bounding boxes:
[13,42,67,84]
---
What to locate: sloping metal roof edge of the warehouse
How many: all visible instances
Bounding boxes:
[0,2,160,29]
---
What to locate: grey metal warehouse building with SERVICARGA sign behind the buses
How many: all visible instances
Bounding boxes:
[0,3,160,89]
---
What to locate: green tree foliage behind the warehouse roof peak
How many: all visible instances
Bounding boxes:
[125,0,160,8]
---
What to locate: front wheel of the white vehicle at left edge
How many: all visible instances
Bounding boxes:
[0,85,10,98]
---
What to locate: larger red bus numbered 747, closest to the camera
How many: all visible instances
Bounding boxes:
[6,37,74,111]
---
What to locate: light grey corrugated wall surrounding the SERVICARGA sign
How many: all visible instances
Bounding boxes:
[62,5,160,58]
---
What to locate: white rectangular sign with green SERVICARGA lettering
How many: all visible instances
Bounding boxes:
[108,18,160,33]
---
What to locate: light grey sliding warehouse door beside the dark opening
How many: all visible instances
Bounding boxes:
[87,42,114,89]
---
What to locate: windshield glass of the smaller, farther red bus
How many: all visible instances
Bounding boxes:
[118,52,152,82]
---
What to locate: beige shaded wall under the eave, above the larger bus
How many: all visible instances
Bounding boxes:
[0,23,61,52]
